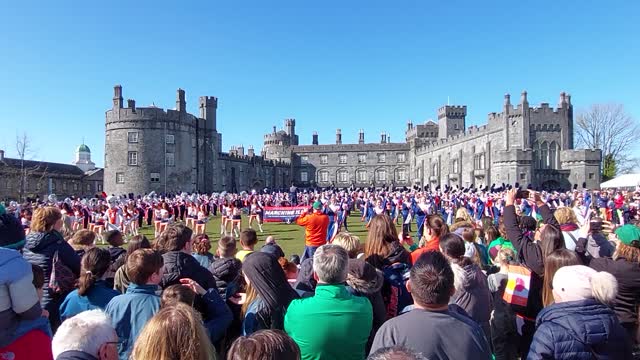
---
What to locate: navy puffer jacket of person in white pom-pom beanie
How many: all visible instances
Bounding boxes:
[527,299,632,360]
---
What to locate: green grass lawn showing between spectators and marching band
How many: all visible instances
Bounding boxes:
[135,214,400,258]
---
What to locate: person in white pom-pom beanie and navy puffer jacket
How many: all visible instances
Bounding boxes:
[527,265,633,360]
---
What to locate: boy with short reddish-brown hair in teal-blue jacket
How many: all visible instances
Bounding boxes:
[105,249,164,360]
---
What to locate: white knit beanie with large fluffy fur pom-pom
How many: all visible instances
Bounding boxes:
[553,265,618,303]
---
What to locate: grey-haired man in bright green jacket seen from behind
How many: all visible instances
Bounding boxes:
[284,245,373,360]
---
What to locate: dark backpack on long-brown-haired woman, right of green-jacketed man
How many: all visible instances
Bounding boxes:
[381,263,413,319]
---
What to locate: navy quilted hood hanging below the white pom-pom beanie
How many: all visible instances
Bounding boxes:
[536,299,620,345]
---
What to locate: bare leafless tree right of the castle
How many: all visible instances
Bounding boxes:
[575,104,640,178]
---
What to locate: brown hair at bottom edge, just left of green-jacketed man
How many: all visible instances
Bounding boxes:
[227,329,300,360]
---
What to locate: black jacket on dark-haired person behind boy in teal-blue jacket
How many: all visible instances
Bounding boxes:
[160,251,217,290]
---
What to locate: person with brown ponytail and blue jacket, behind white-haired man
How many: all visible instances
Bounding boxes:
[60,248,120,321]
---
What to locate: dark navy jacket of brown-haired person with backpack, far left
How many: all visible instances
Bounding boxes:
[23,230,80,307]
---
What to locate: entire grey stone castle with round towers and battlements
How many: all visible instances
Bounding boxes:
[104,85,601,194]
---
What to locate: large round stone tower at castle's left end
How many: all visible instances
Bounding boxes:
[104,85,221,194]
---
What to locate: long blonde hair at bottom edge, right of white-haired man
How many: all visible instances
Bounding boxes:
[131,303,216,360]
